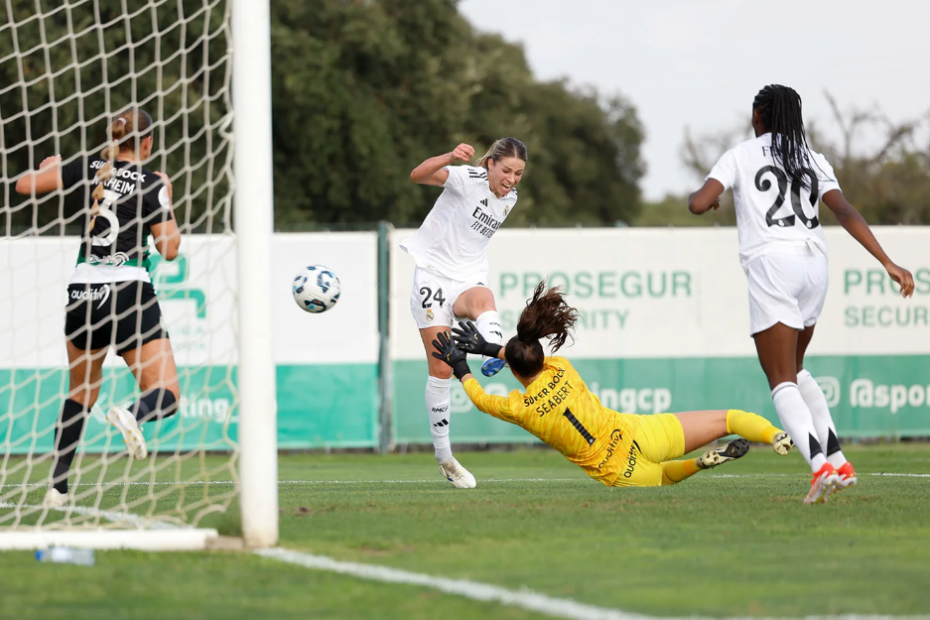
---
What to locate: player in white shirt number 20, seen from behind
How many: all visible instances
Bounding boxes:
[688,84,914,503]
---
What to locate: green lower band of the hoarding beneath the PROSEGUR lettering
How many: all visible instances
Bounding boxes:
[392,355,930,444]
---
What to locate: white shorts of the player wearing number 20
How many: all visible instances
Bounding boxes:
[746,246,827,336]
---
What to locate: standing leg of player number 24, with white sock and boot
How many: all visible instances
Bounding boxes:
[420,326,477,489]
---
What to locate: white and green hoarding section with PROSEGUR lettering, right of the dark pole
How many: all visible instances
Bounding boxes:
[390,227,930,444]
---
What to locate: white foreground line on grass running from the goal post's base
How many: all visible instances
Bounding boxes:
[253,548,926,620]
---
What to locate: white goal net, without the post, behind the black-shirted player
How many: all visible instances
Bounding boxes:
[0,0,258,537]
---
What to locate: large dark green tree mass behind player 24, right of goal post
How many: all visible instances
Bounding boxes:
[272,0,644,226]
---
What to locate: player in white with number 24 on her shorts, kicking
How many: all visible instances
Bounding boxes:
[400,138,526,489]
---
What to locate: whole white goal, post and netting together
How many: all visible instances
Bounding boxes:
[0,0,278,551]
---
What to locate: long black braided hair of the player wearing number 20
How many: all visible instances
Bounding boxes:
[752,84,811,189]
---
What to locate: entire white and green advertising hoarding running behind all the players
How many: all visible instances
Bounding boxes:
[0,227,930,454]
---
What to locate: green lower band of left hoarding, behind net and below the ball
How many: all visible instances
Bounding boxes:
[0,364,379,454]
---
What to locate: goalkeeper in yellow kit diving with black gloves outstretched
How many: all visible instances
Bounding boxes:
[433,282,793,486]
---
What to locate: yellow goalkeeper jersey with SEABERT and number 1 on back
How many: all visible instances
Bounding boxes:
[464,357,639,486]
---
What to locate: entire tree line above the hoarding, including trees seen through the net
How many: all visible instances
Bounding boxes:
[0,0,930,233]
